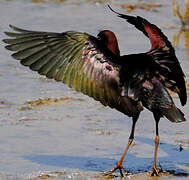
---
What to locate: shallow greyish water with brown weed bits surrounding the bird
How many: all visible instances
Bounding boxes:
[0,0,189,180]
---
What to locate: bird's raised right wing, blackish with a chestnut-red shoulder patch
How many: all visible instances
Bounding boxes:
[109,6,187,105]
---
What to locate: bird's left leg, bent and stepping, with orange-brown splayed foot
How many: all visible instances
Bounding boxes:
[103,116,138,177]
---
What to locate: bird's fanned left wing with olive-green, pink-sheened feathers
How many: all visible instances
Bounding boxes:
[3,25,124,109]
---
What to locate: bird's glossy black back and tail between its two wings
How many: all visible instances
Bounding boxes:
[120,54,185,122]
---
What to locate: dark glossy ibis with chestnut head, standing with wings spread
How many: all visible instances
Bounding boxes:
[3,5,187,176]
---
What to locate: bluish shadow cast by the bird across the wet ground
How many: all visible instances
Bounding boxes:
[24,137,189,177]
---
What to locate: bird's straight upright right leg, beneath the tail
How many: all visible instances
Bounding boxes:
[151,116,160,176]
